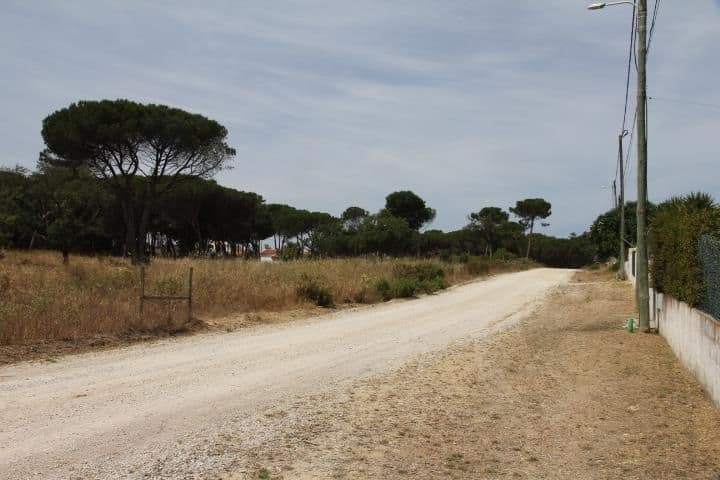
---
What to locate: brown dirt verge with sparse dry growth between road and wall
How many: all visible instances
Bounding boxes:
[228,272,720,480]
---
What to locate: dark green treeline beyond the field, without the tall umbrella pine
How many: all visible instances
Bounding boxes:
[0,163,593,266]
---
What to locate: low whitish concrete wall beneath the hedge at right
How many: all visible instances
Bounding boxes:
[625,249,720,407]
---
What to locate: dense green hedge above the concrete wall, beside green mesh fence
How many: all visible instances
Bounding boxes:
[648,193,720,306]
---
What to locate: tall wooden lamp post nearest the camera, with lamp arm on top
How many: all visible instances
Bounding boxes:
[588,0,650,331]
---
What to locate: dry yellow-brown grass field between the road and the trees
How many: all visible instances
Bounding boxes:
[0,251,527,345]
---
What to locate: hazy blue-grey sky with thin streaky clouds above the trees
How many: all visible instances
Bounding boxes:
[0,0,720,236]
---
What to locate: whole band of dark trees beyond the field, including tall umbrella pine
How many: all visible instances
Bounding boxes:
[0,100,594,266]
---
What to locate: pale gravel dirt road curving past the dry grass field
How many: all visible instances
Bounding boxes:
[0,269,572,479]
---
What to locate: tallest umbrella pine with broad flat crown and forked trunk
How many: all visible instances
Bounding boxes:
[42,99,235,261]
